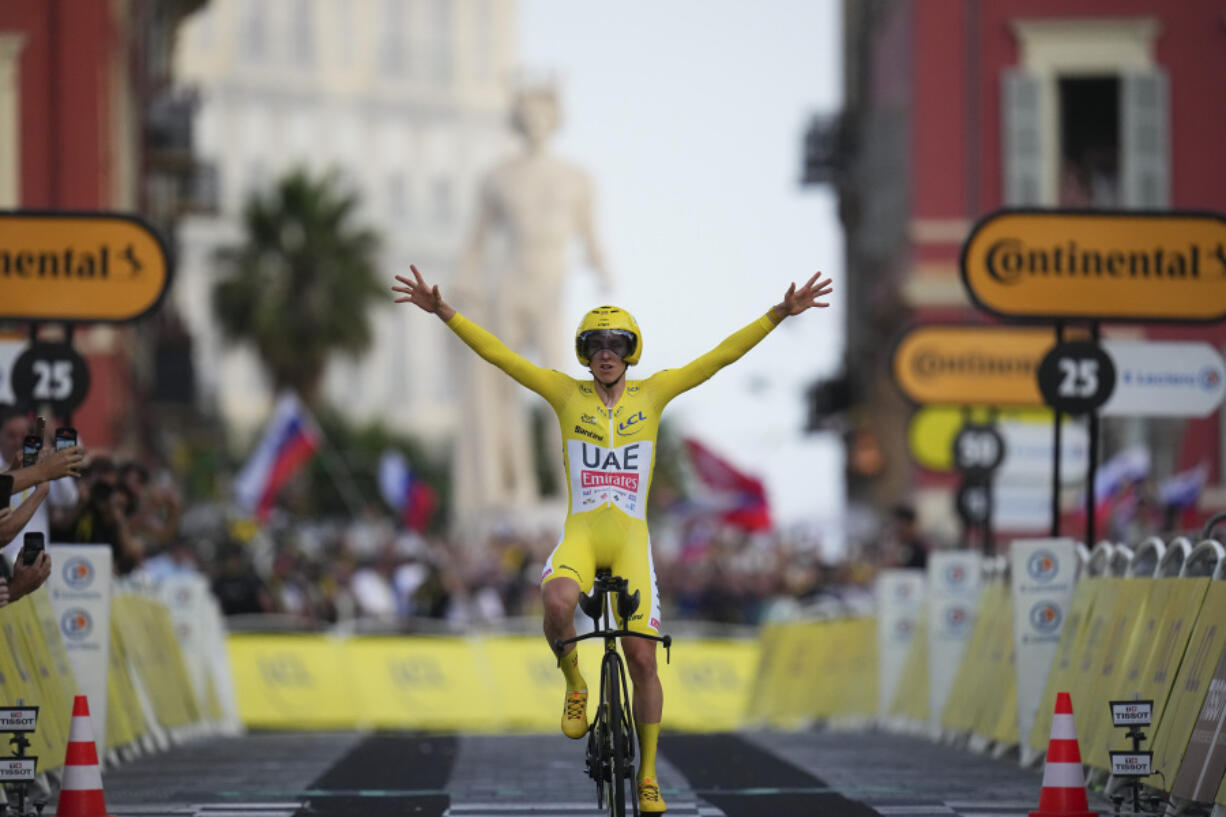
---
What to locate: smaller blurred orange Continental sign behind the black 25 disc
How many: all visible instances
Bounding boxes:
[894,324,1056,406]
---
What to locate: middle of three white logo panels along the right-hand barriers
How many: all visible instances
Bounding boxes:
[928,551,982,734]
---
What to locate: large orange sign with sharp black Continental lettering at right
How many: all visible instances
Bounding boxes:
[961,210,1226,321]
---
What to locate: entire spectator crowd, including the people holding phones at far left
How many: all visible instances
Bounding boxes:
[0,407,868,631]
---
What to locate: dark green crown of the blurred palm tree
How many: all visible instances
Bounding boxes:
[213,169,384,407]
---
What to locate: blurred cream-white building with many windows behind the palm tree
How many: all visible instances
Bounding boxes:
[174,0,515,439]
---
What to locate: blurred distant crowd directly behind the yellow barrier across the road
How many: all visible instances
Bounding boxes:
[203,508,867,631]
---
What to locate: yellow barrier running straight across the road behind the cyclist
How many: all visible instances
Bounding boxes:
[221,634,759,732]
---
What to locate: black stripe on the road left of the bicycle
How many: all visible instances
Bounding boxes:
[298,732,457,817]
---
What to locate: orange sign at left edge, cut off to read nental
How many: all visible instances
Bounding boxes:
[0,211,169,323]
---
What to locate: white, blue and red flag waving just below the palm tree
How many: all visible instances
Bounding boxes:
[234,393,322,523]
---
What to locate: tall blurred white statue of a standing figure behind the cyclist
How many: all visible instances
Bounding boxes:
[454,85,611,530]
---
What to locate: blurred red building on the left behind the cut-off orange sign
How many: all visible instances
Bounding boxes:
[0,0,205,449]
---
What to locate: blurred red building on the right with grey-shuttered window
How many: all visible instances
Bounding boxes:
[805,0,1226,547]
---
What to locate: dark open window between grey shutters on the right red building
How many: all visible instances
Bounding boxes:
[1057,76,1121,209]
